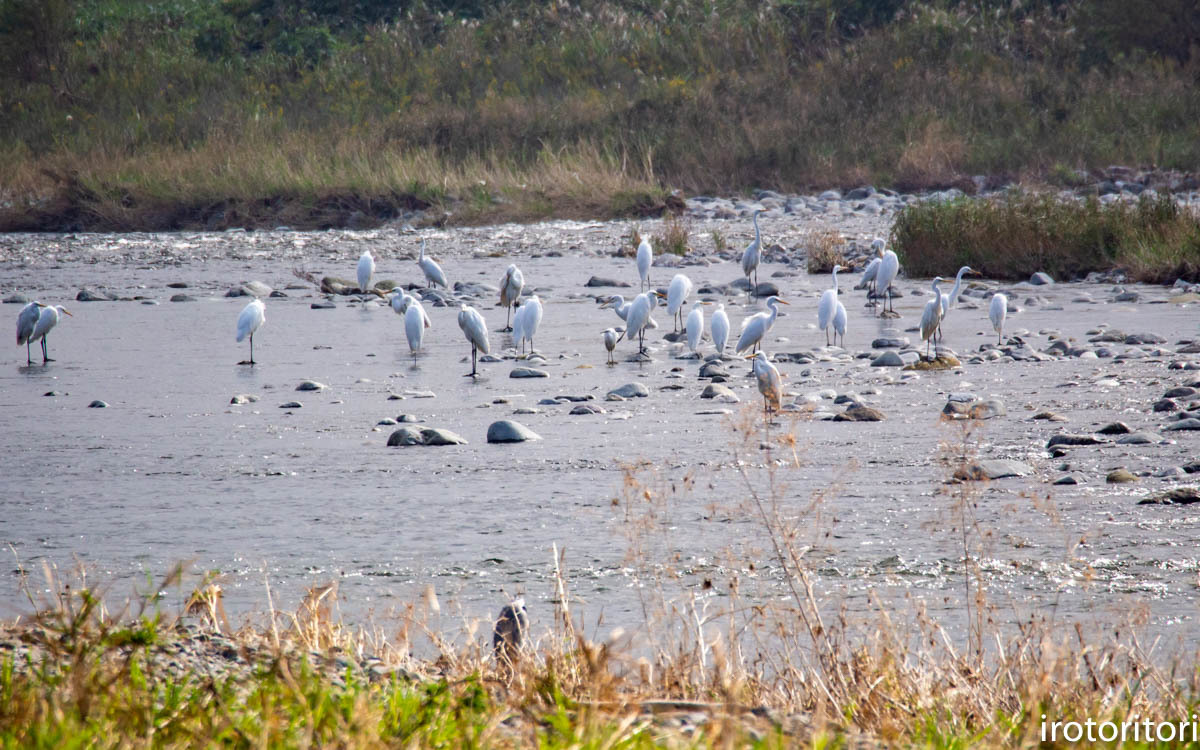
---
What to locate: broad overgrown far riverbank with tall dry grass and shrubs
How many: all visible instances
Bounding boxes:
[0,0,1200,229]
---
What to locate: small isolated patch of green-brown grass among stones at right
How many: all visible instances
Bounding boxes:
[893,193,1200,283]
